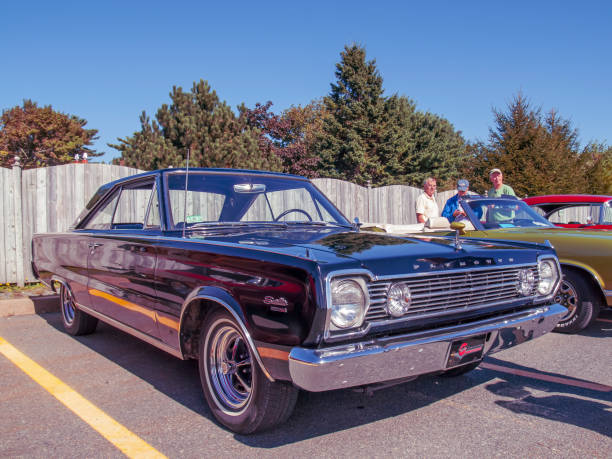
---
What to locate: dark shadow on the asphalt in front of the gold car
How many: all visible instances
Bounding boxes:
[481,357,612,437]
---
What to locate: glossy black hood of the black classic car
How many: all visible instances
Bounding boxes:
[188,228,552,275]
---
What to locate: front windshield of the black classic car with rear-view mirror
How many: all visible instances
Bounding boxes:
[166,171,350,229]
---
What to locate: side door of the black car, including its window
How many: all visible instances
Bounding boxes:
[85,178,160,336]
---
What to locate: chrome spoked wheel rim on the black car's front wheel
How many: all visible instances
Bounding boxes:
[209,326,253,414]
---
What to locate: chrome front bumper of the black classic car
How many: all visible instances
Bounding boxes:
[289,304,567,392]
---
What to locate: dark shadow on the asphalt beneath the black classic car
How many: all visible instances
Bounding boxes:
[41,313,488,448]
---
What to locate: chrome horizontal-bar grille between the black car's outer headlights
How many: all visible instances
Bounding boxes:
[366,265,539,322]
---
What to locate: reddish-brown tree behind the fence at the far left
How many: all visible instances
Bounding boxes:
[0,100,102,169]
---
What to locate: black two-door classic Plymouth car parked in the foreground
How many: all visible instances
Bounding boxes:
[32,169,566,433]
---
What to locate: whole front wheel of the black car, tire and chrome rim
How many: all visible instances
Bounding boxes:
[198,310,298,434]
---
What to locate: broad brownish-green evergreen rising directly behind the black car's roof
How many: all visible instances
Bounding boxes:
[109,80,281,170]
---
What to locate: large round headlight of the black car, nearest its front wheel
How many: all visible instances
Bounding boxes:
[331,279,366,328]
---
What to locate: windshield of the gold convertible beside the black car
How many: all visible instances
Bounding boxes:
[462,199,554,229]
